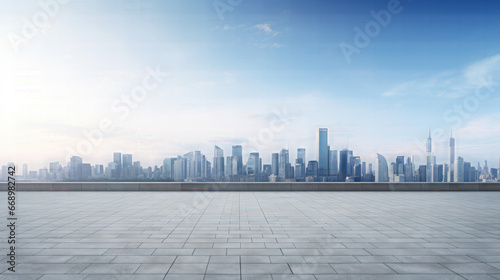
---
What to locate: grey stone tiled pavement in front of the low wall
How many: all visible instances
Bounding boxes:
[0,192,500,280]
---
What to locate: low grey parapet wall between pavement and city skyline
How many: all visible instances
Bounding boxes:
[0,182,500,191]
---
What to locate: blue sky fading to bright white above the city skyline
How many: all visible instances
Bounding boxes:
[0,0,500,169]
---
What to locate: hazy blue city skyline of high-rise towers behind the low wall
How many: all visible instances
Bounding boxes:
[2,128,500,183]
